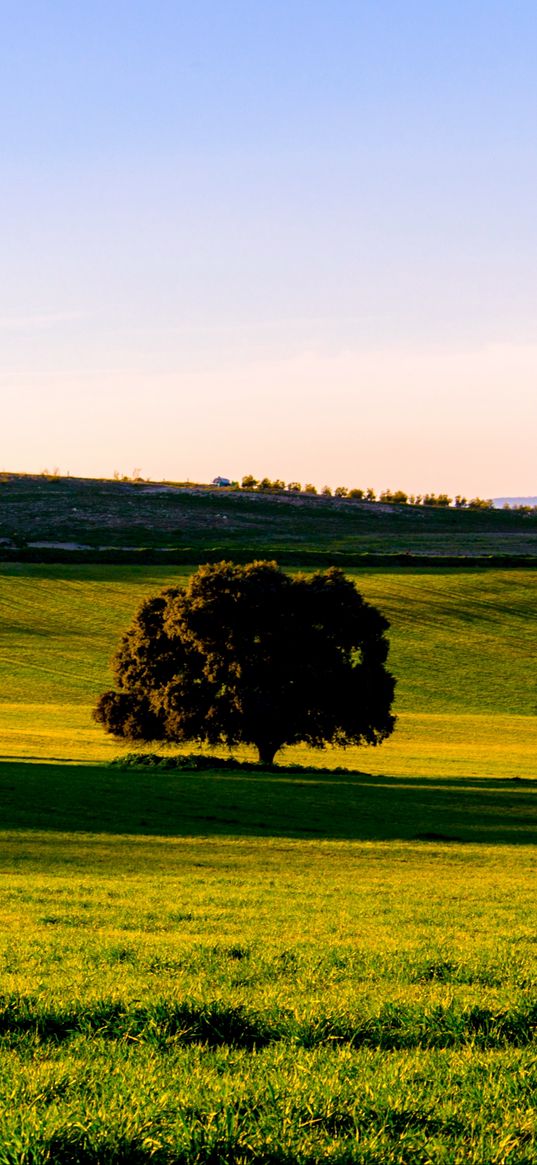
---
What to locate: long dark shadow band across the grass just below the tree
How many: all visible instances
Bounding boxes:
[0,761,537,845]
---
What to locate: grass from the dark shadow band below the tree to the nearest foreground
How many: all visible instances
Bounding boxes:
[0,763,537,1165]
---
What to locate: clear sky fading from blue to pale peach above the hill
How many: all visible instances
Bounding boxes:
[0,0,537,496]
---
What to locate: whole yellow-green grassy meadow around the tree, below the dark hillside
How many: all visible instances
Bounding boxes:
[0,565,537,1165]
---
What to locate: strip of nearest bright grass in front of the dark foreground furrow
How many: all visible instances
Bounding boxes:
[0,1040,536,1165]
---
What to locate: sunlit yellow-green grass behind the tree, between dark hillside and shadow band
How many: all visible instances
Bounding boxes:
[0,565,537,777]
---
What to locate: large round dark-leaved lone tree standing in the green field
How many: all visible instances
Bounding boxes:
[93,562,395,764]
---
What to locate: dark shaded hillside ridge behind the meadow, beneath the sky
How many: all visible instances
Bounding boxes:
[0,473,537,564]
